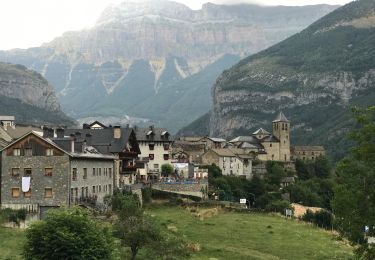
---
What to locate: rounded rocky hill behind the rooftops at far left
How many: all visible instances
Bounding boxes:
[0,63,75,125]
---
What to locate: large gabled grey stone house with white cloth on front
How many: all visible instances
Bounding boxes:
[0,132,115,217]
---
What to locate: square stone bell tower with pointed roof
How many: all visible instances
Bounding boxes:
[272,112,290,162]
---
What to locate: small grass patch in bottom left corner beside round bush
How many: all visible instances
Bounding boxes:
[0,227,25,260]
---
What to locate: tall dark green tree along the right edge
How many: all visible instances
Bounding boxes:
[332,106,375,259]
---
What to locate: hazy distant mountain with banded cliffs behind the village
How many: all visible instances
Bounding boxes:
[0,1,337,131]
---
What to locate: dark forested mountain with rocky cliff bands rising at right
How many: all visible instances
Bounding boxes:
[180,0,375,158]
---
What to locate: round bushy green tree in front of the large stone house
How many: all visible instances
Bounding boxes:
[23,208,114,259]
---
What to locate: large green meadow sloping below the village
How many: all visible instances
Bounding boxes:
[148,207,352,260]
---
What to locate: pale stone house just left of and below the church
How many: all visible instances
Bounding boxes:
[202,148,254,179]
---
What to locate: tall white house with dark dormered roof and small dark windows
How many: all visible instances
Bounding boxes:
[134,126,173,180]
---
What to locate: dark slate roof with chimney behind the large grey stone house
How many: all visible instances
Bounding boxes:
[64,128,134,154]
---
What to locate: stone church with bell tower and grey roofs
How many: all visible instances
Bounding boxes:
[229,112,291,162]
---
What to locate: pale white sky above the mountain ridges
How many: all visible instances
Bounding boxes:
[0,0,352,50]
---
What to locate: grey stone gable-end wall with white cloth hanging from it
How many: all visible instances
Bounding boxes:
[1,152,70,211]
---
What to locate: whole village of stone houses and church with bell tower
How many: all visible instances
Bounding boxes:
[0,112,325,219]
